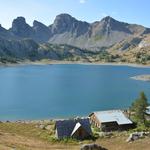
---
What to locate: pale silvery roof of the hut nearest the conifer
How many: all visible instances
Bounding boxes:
[94,110,132,125]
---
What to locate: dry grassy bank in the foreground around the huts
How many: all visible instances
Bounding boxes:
[0,122,150,150]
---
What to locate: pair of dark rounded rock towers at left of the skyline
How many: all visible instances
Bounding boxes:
[9,17,51,43]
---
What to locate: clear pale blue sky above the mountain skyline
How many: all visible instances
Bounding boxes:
[0,0,150,28]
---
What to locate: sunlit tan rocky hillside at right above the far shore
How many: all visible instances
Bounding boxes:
[108,34,150,64]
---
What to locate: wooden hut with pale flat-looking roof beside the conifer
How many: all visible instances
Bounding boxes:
[89,110,133,131]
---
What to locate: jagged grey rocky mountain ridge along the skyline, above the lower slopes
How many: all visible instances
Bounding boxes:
[0,14,150,50]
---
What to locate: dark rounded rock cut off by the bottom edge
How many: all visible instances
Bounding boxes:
[81,144,107,150]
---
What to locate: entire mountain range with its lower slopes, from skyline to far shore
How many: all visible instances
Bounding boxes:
[0,14,150,63]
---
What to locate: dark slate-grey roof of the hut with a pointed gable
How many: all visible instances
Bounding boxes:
[55,118,92,138]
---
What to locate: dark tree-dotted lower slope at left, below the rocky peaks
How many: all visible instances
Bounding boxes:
[0,38,110,63]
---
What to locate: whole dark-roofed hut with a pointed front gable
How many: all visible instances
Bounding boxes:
[55,118,92,140]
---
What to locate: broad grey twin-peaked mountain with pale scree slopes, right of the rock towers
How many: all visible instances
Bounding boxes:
[49,14,149,50]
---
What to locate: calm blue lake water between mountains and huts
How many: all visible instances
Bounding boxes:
[0,64,150,120]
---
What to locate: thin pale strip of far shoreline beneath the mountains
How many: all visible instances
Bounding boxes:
[0,61,150,68]
